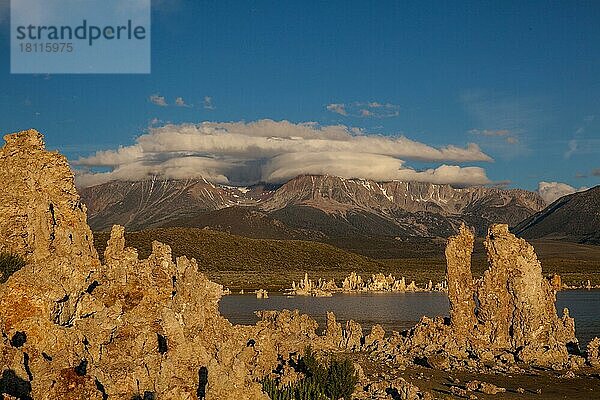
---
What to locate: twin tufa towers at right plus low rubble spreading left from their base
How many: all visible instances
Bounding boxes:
[380,225,583,372]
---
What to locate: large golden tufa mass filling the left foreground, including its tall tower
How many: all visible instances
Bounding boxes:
[0,130,315,399]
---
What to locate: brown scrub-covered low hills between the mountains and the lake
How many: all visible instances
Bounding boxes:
[94,228,600,290]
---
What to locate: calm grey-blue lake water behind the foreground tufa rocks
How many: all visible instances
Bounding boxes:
[220,290,600,346]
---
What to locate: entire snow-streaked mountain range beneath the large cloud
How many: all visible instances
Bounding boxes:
[81,175,546,240]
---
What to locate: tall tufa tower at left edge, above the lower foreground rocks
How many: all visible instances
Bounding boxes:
[0,129,97,262]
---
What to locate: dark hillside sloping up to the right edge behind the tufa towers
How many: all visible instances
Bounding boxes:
[514,186,600,244]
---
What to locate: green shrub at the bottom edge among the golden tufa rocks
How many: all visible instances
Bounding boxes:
[262,347,358,400]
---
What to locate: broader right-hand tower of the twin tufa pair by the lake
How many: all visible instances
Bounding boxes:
[477,225,577,365]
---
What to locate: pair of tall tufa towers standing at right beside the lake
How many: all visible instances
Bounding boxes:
[446,225,577,365]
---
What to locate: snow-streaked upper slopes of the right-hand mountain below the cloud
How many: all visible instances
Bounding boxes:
[264,175,545,225]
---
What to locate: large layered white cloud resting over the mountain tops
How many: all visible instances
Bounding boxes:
[75,120,492,186]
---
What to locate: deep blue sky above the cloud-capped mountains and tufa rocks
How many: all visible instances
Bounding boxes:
[0,0,600,195]
